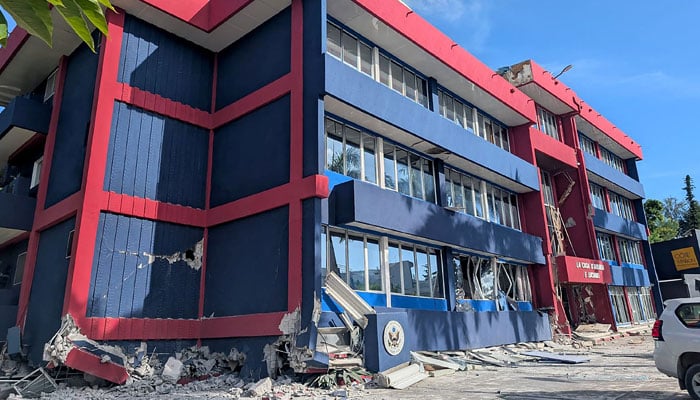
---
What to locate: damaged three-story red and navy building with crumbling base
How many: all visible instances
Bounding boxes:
[0,0,653,380]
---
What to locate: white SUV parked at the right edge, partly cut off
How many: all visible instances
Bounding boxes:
[651,297,700,400]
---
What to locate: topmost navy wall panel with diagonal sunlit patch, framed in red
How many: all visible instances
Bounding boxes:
[117,14,214,111]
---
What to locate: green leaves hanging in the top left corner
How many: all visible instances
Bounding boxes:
[0,0,114,51]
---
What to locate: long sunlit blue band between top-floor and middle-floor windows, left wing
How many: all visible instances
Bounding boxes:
[325,55,539,190]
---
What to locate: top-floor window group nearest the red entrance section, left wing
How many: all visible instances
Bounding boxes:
[438,89,510,151]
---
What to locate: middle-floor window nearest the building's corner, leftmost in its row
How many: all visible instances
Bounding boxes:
[325,118,377,184]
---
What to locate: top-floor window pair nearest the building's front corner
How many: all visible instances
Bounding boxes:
[326,22,428,107]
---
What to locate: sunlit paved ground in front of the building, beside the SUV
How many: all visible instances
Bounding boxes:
[362,336,690,400]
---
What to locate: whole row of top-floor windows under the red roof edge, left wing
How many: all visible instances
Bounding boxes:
[326,22,510,155]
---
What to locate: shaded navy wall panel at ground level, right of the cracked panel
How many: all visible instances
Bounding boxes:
[204,206,289,317]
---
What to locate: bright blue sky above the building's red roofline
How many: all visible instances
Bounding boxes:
[404,0,700,199]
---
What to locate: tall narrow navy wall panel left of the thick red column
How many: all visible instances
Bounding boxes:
[45,45,99,207]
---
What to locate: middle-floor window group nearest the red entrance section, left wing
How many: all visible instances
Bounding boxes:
[445,168,520,230]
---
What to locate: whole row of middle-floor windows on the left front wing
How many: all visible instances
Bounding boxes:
[325,117,521,230]
